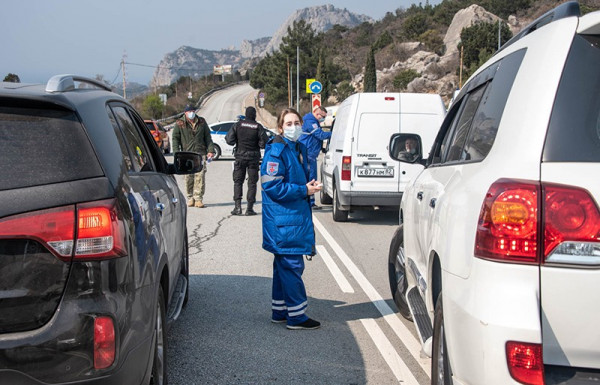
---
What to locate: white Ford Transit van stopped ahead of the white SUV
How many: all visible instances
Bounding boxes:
[321,93,446,222]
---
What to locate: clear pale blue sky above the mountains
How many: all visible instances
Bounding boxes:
[0,0,440,84]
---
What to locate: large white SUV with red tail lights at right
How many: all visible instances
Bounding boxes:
[389,2,600,385]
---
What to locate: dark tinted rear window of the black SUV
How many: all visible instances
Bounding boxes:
[0,106,103,191]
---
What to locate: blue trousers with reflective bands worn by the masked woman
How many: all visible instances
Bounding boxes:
[271,254,308,325]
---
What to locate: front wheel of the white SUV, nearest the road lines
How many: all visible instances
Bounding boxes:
[388,225,412,321]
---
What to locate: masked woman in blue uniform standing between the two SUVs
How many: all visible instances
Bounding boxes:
[260,108,321,330]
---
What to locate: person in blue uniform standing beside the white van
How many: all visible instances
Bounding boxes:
[299,106,331,210]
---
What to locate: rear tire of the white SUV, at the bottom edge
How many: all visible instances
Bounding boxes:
[431,293,452,385]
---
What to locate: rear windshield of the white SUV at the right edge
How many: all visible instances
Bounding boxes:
[543,35,600,162]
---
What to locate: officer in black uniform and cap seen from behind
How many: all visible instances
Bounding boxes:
[225,107,268,215]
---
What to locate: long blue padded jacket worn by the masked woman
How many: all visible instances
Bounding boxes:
[260,135,315,255]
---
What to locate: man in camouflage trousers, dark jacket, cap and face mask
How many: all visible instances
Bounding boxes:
[173,105,215,208]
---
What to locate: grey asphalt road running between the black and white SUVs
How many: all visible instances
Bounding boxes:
[167,86,431,385]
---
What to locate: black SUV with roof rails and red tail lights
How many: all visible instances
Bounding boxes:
[0,75,202,385]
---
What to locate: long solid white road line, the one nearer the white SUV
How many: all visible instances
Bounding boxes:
[313,215,431,377]
